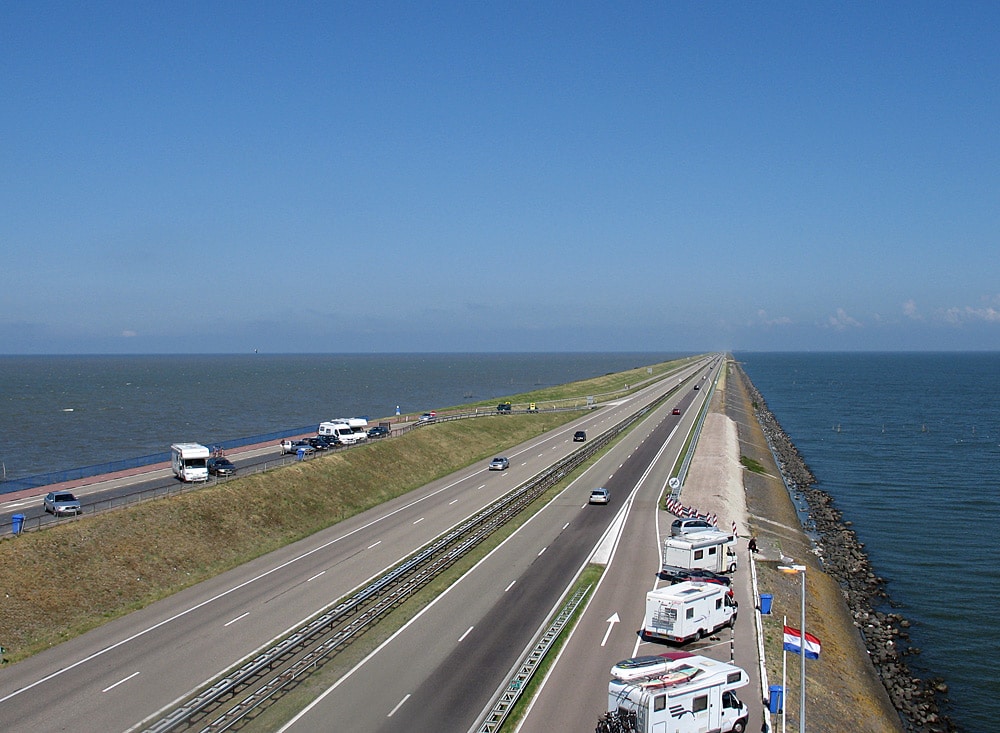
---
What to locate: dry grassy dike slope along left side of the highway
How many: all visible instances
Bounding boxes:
[0,360,687,661]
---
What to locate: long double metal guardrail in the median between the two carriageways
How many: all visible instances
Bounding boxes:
[146,391,669,733]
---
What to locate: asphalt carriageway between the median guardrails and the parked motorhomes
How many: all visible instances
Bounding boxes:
[281,364,724,733]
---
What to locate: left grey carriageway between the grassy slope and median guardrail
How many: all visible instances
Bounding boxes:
[0,358,720,731]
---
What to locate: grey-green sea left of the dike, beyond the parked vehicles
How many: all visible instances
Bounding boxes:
[0,352,678,479]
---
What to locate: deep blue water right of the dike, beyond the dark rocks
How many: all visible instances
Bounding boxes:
[735,353,1000,731]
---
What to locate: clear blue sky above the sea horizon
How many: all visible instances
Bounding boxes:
[0,2,1000,354]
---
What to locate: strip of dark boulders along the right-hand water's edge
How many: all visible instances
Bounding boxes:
[729,361,958,733]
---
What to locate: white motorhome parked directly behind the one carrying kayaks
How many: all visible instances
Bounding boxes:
[642,580,739,644]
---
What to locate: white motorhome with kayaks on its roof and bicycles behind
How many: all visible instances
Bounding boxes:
[608,655,750,733]
